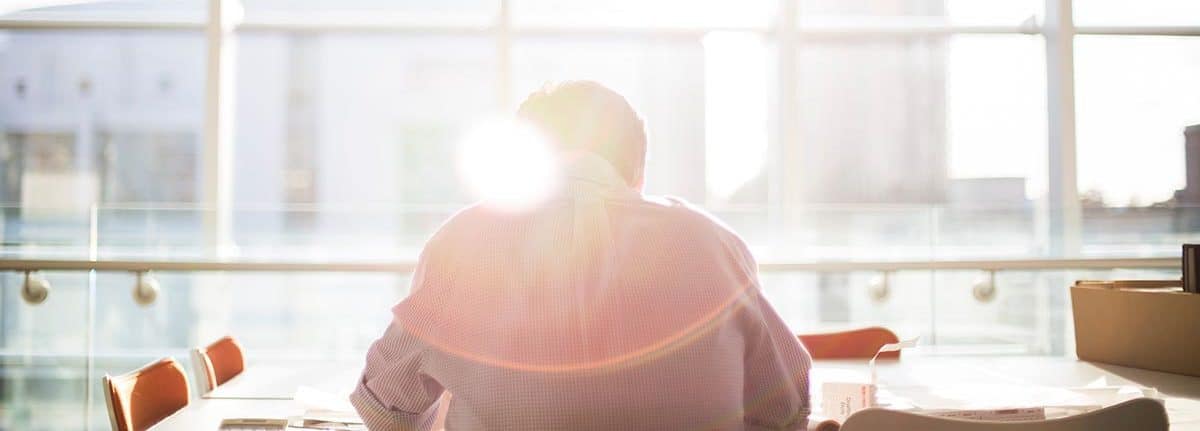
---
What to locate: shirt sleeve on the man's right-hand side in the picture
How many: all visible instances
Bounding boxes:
[743,246,812,430]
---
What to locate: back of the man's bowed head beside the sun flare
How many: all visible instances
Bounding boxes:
[517,80,646,187]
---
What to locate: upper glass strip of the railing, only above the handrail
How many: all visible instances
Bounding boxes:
[9,204,1200,262]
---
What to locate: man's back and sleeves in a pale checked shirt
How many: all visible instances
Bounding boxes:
[354,154,809,430]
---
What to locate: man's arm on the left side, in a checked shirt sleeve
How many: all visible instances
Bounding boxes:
[350,322,443,431]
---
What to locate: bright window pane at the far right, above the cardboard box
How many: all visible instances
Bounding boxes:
[1075,36,1200,206]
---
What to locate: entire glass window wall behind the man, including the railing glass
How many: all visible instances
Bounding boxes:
[0,0,1200,430]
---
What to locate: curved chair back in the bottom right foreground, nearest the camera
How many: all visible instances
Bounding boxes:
[841,399,1169,431]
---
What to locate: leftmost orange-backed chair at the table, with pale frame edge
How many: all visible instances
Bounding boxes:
[103,358,188,431]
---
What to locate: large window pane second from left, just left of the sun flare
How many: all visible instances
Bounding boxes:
[235,32,497,258]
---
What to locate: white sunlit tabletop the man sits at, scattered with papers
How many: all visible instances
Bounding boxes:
[155,353,1200,431]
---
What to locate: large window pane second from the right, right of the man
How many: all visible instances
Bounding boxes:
[780,36,1045,258]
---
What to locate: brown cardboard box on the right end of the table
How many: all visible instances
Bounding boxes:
[1070,282,1200,376]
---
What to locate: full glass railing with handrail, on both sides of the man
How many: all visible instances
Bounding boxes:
[0,205,1200,430]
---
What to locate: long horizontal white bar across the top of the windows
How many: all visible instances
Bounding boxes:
[0,11,1200,36]
